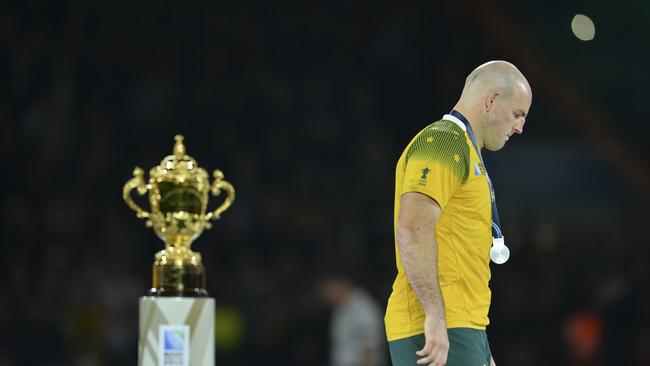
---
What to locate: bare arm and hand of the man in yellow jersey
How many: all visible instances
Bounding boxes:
[396,192,449,365]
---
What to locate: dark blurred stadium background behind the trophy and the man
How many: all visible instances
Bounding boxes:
[0,0,650,366]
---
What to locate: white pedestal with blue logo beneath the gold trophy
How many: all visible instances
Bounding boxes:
[138,296,215,366]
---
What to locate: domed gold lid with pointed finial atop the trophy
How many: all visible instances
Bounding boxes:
[149,135,208,185]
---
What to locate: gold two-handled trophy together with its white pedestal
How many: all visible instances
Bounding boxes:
[123,136,235,366]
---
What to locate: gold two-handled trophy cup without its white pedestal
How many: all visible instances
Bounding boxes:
[123,135,235,296]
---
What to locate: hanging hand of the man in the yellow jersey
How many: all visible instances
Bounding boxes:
[415,314,449,366]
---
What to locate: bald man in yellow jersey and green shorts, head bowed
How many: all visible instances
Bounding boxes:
[385,61,532,366]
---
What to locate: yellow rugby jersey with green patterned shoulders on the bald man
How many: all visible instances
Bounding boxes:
[385,115,492,364]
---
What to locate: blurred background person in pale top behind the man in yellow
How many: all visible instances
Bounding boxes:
[319,274,386,366]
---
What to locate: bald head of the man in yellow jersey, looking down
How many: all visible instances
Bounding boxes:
[454,61,533,151]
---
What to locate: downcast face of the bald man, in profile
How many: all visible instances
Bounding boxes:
[483,85,532,151]
